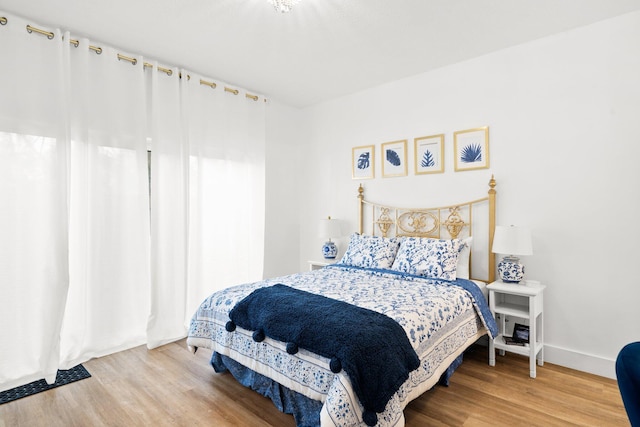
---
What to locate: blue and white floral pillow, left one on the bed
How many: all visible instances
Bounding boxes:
[340,233,400,268]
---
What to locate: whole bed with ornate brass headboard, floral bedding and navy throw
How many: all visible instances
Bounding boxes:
[187,177,497,427]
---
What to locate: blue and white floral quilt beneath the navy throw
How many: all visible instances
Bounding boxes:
[187,265,495,426]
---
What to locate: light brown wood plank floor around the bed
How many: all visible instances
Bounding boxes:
[0,340,629,427]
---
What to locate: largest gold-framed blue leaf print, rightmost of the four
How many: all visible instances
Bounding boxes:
[453,126,489,172]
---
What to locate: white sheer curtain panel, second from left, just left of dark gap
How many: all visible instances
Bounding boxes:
[61,38,150,368]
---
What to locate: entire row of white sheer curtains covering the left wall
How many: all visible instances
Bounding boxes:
[0,12,265,390]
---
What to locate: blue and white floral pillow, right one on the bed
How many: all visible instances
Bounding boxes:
[391,237,463,280]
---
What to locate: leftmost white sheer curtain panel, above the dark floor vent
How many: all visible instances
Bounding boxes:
[0,15,69,391]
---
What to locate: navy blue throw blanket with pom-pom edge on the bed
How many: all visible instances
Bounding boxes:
[227,284,420,425]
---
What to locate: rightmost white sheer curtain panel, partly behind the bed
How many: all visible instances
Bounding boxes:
[183,75,265,314]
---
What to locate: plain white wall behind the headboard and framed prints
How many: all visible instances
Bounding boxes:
[294,12,640,377]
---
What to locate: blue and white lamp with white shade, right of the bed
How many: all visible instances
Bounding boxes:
[492,225,533,283]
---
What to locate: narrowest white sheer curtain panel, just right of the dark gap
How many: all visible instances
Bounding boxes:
[147,63,185,348]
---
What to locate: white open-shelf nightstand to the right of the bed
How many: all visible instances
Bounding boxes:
[487,280,545,378]
